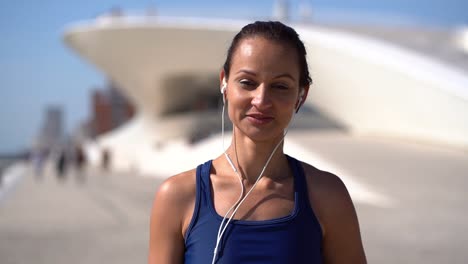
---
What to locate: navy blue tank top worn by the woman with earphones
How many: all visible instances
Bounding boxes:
[185,156,322,264]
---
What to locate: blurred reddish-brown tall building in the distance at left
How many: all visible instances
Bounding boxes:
[91,83,135,137]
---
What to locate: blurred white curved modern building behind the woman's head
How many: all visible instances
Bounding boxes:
[64,11,468,174]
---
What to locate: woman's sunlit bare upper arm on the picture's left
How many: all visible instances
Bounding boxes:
[148,171,195,264]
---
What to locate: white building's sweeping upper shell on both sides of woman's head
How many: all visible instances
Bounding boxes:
[64,17,468,148]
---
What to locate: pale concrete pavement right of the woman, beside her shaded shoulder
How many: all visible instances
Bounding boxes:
[288,131,468,264]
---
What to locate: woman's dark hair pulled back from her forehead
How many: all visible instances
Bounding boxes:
[223,21,312,87]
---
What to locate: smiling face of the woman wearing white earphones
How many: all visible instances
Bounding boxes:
[221,37,299,141]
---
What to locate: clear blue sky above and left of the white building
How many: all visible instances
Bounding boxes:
[0,0,468,153]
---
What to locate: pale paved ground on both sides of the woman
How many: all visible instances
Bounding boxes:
[0,131,468,264]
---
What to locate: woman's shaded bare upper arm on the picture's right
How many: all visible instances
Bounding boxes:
[309,167,366,264]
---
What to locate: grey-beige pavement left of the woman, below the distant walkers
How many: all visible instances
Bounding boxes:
[0,163,163,264]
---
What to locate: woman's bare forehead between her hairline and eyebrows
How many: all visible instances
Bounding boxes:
[231,37,299,72]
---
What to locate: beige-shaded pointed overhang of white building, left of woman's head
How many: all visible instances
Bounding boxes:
[64,17,243,116]
